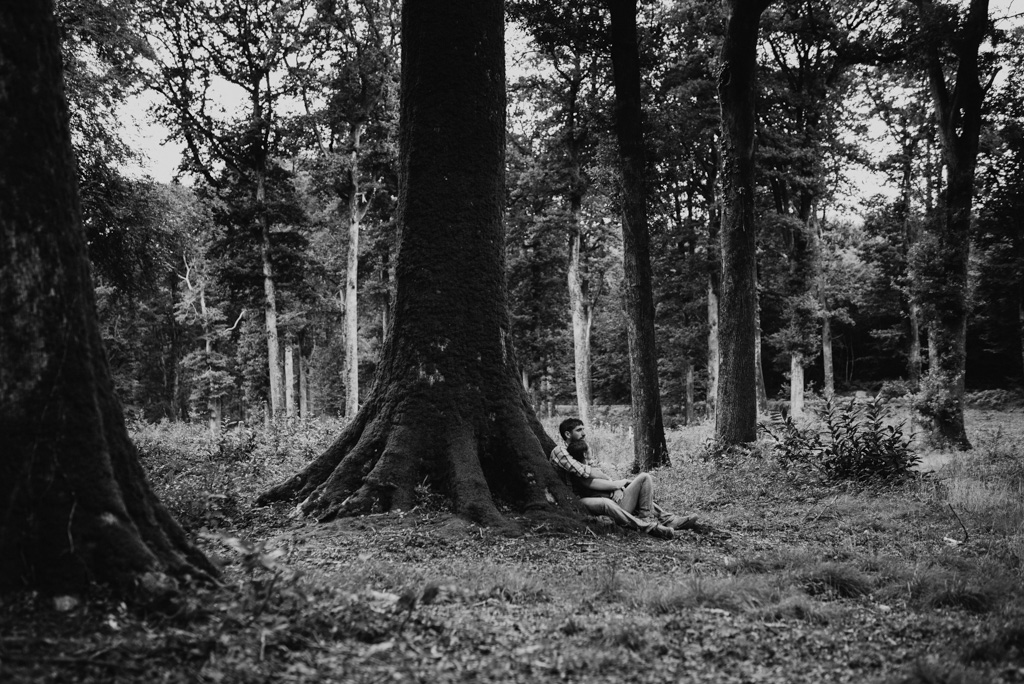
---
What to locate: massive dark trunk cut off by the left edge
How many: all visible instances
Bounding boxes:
[0,0,214,595]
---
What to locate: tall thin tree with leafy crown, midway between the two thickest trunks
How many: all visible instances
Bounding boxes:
[150,0,311,416]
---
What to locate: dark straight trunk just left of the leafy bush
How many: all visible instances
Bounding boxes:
[715,0,768,444]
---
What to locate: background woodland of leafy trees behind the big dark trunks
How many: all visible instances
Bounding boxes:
[66,0,1024,431]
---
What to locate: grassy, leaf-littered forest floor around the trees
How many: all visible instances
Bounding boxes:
[0,411,1024,684]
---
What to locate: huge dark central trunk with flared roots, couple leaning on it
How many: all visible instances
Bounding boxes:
[260,0,577,523]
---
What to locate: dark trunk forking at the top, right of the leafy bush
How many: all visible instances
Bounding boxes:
[918,0,988,448]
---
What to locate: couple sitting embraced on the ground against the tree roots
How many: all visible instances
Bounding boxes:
[550,418,705,540]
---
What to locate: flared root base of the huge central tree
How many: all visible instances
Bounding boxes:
[257,383,580,526]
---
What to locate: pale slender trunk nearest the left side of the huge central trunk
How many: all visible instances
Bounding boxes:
[345,124,362,418]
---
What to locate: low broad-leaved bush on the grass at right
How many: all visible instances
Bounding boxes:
[760,398,921,481]
